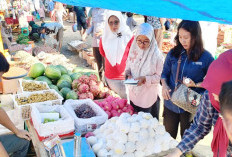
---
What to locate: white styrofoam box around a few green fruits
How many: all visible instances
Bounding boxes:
[31,104,74,137]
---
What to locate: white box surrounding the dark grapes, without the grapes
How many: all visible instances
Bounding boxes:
[64,99,108,133]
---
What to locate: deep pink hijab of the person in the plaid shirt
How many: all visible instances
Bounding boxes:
[202,50,232,157]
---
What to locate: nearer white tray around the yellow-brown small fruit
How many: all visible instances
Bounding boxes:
[12,89,63,120]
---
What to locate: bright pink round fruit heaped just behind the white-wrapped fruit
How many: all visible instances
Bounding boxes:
[95,96,134,119]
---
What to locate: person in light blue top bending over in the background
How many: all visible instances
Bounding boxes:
[40,22,63,52]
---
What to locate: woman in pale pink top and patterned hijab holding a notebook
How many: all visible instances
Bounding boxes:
[126,23,164,119]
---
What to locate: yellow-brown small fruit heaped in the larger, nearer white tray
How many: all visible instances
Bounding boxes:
[15,92,58,105]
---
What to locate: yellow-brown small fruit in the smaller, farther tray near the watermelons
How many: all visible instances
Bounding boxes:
[22,81,48,92]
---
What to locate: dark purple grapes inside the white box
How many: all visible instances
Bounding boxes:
[74,104,96,119]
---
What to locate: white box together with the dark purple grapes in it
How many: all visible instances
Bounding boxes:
[64,99,108,133]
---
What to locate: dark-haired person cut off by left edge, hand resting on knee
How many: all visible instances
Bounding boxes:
[0,53,30,157]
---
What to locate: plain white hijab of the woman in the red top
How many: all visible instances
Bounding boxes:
[102,11,133,66]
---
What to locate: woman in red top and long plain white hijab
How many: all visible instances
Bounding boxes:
[99,11,133,98]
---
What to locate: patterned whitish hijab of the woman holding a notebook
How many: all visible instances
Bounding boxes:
[126,23,163,92]
